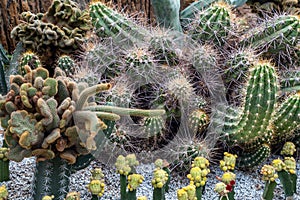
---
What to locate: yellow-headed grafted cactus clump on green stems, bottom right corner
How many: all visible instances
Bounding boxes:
[261,142,297,200]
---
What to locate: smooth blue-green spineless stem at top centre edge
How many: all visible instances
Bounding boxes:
[151,0,182,32]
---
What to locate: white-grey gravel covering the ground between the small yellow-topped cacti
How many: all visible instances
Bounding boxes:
[0,134,300,200]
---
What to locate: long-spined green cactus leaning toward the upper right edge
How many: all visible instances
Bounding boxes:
[242,15,300,54]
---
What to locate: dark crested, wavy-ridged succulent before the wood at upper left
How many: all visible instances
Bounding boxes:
[11,0,92,67]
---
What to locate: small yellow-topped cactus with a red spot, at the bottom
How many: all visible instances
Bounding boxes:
[215,152,237,200]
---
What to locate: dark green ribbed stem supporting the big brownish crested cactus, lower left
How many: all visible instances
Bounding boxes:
[32,157,71,200]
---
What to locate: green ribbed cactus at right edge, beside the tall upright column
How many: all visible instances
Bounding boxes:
[273,92,300,142]
